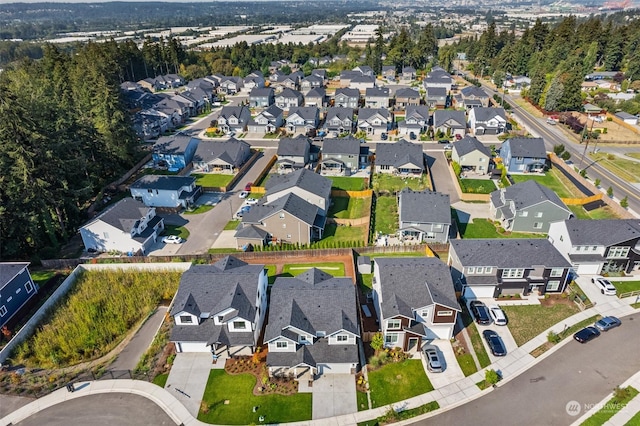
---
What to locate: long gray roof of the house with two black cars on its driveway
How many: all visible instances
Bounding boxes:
[451,238,571,268]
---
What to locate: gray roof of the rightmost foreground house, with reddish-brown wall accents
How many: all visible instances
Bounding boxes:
[374,257,460,318]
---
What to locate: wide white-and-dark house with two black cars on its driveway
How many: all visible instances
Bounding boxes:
[447,238,571,300]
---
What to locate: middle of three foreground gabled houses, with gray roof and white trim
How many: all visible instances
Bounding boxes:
[264,268,360,380]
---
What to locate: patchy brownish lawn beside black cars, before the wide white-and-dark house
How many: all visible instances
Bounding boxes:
[502,303,580,346]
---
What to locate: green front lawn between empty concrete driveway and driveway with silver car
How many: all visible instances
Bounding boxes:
[369,359,433,408]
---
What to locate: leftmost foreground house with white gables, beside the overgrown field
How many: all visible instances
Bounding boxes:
[170,256,268,361]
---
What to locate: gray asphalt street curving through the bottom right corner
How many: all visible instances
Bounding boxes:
[415,314,640,426]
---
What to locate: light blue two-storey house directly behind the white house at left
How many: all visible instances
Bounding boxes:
[129,175,202,208]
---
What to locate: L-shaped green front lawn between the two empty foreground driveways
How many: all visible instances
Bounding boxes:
[198,370,311,425]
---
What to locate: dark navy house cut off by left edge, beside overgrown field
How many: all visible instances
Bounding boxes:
[0,262,38,327]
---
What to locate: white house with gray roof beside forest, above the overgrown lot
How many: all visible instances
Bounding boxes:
[80,198,164,255]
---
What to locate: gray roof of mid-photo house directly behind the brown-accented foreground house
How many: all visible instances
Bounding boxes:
[399,188,451,225]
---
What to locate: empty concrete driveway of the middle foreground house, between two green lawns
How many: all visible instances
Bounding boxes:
[311,374,358,420]
